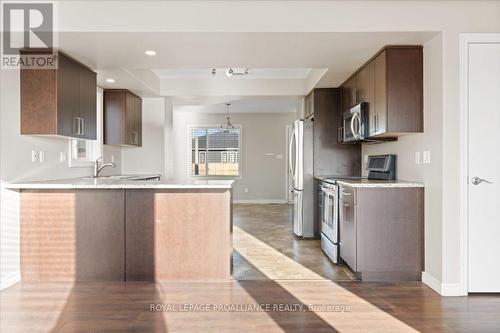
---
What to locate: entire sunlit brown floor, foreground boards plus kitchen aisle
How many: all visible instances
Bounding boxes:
[0,201,500,333]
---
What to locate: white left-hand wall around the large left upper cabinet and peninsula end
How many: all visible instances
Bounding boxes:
[0,70,120,287]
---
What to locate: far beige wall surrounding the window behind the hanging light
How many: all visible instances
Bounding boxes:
[174,111,295,202]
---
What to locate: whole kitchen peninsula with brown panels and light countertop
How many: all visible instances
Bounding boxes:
[9,177,233,282]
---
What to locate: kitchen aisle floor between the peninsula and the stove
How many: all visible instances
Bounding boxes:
[233,204,356,281]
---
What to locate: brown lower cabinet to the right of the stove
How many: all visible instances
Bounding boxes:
[339,186,424,281]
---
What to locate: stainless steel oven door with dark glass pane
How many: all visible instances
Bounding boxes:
[321,185,339,244]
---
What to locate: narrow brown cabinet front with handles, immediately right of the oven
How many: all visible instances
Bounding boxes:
[339,187,357,271]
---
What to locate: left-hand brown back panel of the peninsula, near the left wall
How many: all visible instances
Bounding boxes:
[21,190,125,282]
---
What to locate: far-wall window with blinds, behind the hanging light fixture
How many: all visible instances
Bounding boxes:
[188,126,241,177]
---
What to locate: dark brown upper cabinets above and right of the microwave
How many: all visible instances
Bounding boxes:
[342,46,424,140]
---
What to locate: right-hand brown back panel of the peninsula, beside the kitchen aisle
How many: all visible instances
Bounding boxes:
[126,189,232,281]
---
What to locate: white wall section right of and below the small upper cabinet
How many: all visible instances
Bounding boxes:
[122,98,165,175]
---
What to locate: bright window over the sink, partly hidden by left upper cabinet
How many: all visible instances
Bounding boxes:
[68,88,103,167]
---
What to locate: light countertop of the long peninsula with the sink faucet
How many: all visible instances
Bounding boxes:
[5,175,234,190]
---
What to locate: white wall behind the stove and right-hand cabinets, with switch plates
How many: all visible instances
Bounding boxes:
[362,35,443,280]
